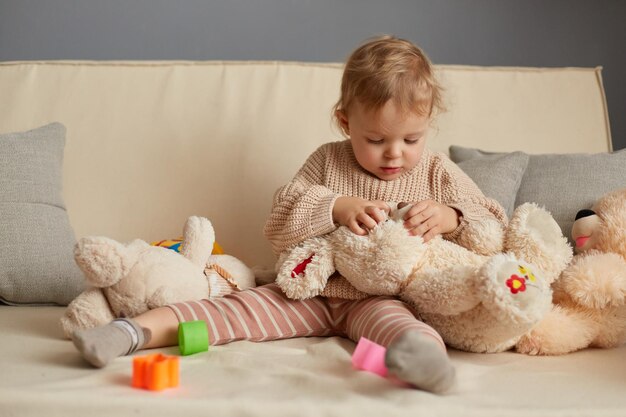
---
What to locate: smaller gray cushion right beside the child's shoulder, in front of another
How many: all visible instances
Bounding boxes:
[449,146,528,217]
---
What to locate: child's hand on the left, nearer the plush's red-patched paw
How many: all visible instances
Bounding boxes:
[333,197,390,236]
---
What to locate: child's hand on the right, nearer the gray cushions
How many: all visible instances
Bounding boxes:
[404,200,459,242]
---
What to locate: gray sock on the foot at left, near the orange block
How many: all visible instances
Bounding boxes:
[72,319,151,368]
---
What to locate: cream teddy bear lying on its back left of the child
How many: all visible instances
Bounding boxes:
[61,216,255,338]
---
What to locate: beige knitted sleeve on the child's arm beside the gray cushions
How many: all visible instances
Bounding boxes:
[435,155,508,249]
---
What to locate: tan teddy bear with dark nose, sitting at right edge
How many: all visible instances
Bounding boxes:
[516,188,626,355]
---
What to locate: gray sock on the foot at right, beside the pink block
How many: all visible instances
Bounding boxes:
[385,331,455,394]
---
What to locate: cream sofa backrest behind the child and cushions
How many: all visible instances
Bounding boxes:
[0,61,611,267]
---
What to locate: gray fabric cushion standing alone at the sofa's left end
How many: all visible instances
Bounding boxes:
[0,123,84,305]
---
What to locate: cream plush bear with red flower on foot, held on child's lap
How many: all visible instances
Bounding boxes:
[276,204,572,352]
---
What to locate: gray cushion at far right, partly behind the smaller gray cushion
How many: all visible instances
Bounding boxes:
[451,147,626,238]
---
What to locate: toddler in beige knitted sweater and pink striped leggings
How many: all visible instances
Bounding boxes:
[73,36,506,392]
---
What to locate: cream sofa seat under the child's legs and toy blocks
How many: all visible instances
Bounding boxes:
[0,306,626,417]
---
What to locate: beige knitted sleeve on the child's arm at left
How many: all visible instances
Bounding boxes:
[263,146,339,254]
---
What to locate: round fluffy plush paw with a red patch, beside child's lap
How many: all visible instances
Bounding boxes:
[276,237,335,299]
